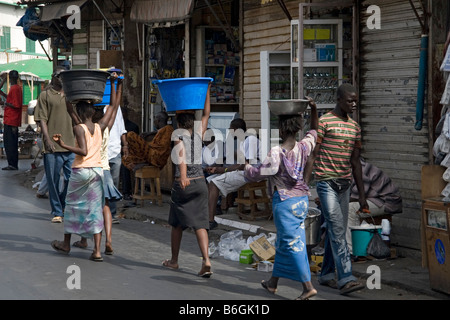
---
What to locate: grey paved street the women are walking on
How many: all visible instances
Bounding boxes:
[0,159,442,303]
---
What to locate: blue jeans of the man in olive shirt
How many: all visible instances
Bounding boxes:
[44,152,75,217]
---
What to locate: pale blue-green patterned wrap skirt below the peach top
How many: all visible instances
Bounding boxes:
[64,168,105,239]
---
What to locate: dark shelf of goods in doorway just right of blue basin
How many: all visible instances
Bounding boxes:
[204,28,240,107]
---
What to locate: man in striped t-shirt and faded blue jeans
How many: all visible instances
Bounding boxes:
[305,84,368,294]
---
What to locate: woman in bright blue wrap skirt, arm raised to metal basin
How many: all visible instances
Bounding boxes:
[245,98,318,300]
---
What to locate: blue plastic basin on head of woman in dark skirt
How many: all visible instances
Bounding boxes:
[153,77,213,111]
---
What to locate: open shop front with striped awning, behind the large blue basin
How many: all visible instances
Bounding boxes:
[130,0,241,190]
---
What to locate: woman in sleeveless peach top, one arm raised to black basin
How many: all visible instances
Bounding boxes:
[51,77,121,261]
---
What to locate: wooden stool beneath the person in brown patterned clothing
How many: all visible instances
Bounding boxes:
[133,166,162,207]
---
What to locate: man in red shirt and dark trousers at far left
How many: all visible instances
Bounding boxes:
[0,70,22,170]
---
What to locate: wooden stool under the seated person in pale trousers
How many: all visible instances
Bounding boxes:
[235,180,272,220]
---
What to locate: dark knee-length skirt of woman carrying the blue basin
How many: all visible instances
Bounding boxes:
[168,178,209,230]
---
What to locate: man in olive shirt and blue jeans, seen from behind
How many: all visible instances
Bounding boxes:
[34,69,75,223]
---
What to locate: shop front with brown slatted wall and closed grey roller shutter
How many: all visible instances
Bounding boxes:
[242,0,449,256]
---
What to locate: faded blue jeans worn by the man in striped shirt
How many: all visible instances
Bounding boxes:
[317,181,356,288]
